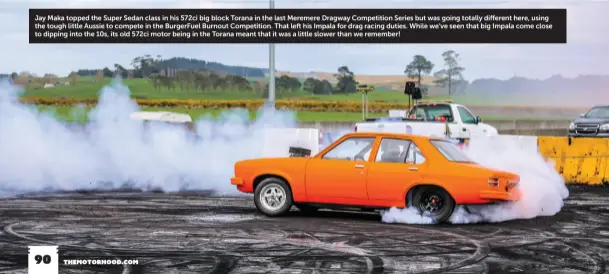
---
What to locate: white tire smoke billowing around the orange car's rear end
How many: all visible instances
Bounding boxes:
[382,135,569,224]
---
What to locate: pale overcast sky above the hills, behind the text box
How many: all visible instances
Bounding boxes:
[0,0,609,80]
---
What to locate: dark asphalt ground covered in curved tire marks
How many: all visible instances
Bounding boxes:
[0,187,609,274]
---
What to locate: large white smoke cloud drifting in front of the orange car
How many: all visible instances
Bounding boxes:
[0,80,295,195]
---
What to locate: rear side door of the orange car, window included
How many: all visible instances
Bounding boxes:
[367,138,427,202]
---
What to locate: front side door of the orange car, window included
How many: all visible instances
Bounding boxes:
[305,137,376,202]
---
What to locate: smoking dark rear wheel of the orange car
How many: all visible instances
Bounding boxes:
[411,186,455,224]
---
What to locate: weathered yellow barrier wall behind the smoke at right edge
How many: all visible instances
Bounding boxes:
[537,136,609,185]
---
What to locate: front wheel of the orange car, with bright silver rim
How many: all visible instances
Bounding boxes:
[254,178,294,217]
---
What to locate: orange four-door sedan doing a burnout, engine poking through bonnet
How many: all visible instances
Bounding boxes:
[231,132,520,223]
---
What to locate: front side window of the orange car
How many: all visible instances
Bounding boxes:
[322,138,375,161]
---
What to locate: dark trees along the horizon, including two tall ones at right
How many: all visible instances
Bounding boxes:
[5,50,467,96]
